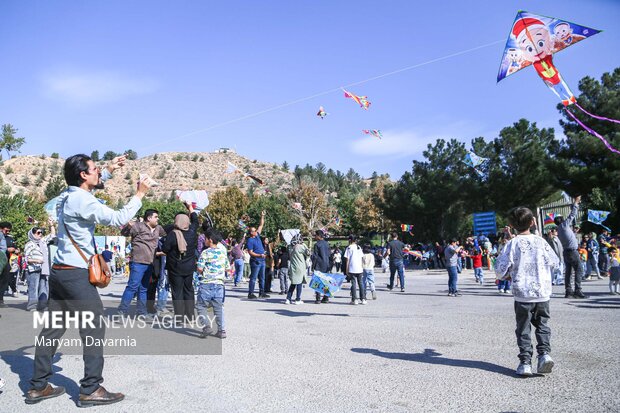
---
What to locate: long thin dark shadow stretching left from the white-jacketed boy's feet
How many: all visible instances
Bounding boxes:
[351,348,518,377]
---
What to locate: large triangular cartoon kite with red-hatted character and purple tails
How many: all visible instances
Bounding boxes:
[497,11,620,154]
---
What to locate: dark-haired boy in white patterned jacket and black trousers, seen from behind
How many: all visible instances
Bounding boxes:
[495,207,560,376]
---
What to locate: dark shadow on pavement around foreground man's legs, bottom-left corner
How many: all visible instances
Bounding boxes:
[2,346,80,403]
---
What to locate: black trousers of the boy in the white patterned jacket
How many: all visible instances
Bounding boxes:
[515,301,551,364]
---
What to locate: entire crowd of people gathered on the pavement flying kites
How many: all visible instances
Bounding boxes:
[0,155,620,406]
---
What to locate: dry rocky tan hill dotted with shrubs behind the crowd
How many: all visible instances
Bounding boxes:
[0,150,293,200]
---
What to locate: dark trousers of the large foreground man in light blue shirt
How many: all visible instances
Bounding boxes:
[30,268,105,394]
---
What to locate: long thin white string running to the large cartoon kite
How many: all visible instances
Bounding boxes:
[146,40,504,148]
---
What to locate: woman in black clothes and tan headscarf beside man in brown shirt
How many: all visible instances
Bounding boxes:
[162,203,198,321]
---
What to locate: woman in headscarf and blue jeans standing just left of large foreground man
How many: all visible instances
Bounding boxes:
[24,220,56,311]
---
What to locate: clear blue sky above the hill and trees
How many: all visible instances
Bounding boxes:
[0,0,620,178]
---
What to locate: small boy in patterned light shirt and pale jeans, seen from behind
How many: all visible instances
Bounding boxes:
[196,228,230,338]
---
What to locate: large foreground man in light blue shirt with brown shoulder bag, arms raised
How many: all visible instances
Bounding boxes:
[25,155,149,407]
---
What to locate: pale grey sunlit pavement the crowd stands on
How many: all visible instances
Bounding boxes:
[0,271,620,412]
